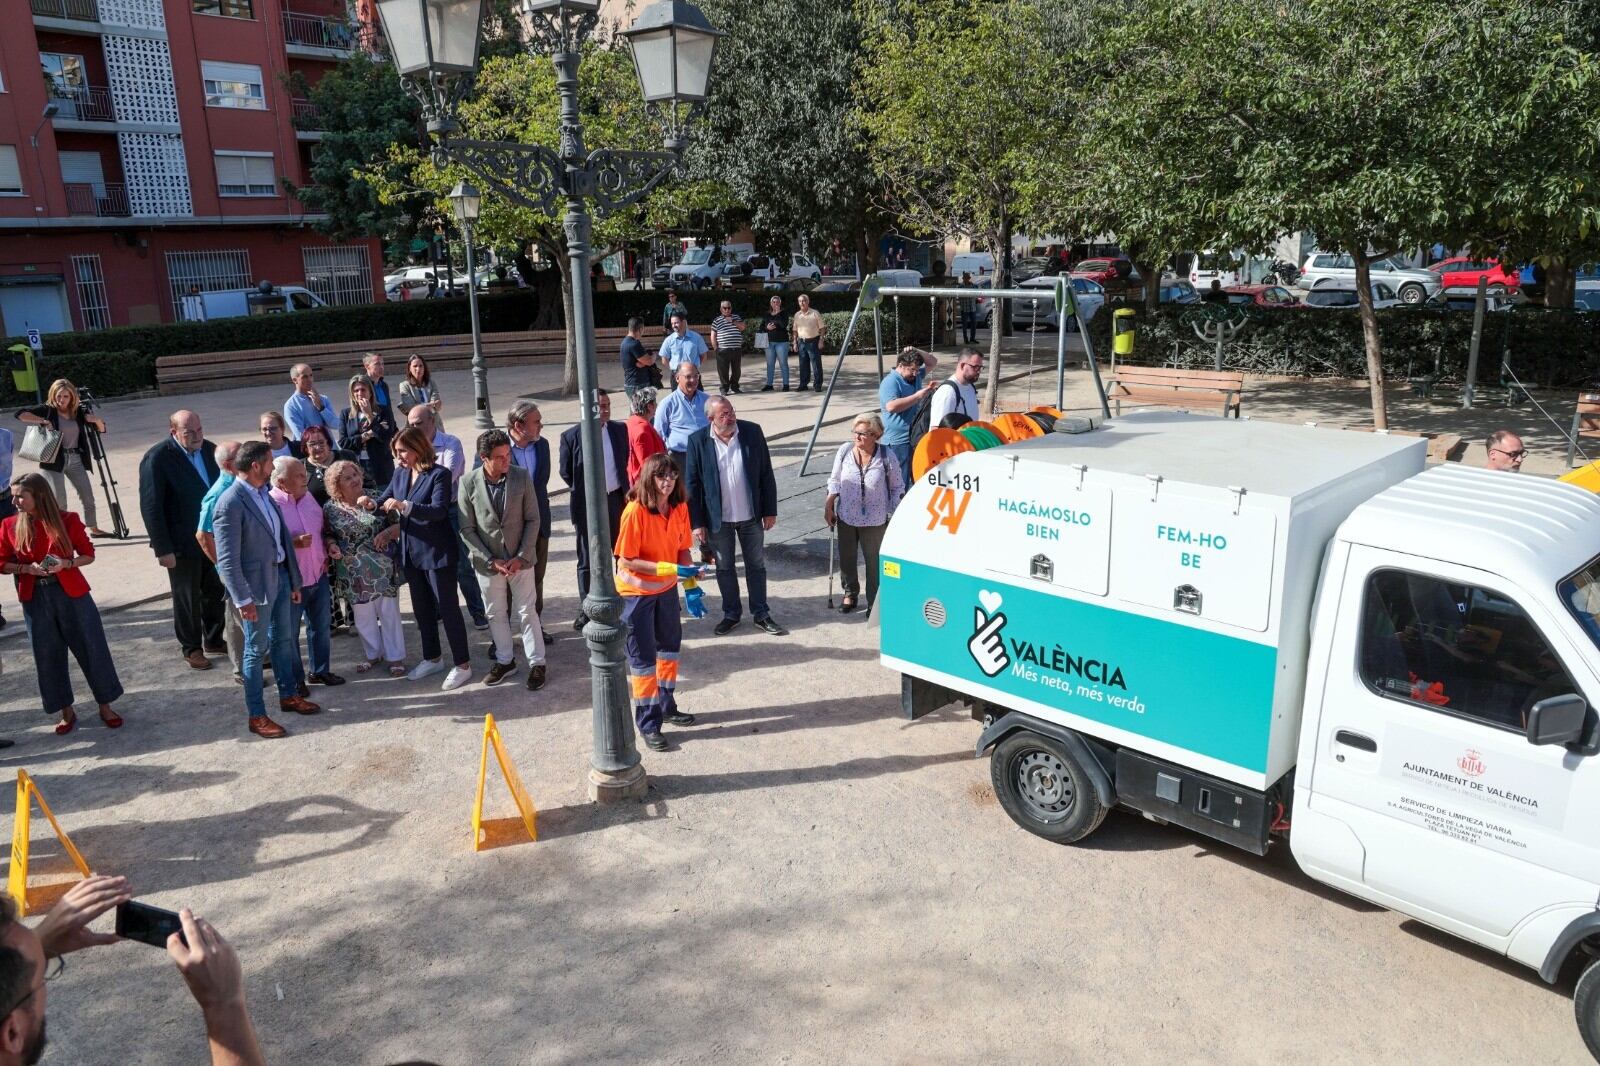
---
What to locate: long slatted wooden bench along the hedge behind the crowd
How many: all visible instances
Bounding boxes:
[155,323,710,397]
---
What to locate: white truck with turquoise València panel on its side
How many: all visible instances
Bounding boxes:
[877,413,1600,1058]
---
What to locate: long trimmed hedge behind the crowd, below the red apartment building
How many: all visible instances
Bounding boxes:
[0,290,876,403]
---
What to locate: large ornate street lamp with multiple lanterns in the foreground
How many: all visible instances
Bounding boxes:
[378,0,722,804]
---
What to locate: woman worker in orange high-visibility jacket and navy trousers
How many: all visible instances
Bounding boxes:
[616,453,706,751]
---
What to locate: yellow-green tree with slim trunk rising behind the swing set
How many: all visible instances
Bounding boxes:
[854,0,1070,410]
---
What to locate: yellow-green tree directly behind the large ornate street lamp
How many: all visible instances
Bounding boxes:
[362,42,723,395]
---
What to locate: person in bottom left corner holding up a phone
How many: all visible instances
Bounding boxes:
[0,876,266,1066]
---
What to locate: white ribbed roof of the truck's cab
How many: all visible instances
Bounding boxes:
[1339,464,1600,589]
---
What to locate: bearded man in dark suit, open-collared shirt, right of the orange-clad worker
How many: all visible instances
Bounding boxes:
[683,395,789,637]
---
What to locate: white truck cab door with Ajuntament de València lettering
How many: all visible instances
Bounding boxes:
[1309,547,1600,948]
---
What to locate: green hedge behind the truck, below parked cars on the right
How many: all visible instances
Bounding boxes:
[1090,307,1600,389]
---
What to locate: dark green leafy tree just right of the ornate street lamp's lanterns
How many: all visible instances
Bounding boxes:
[690,0,888,269]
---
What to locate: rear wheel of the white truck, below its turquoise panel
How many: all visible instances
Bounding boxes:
[989,730,1106,844]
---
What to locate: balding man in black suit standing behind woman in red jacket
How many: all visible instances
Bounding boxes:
[139,411,227,671]
